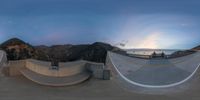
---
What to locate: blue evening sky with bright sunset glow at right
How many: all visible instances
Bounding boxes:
[0,0,200,49]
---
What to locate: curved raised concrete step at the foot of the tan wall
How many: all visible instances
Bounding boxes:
[21,69,90,86]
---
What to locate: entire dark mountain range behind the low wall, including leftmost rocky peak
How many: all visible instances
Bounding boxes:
[0,38,125,63]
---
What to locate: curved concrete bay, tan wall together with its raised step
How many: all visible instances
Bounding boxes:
[21,59,90,86]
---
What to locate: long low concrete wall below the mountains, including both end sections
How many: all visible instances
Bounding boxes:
[4,59,110,80]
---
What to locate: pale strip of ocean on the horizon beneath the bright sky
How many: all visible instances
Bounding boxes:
[126,49,183,55]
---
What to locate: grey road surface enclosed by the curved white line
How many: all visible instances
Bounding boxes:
[109,52,200,86]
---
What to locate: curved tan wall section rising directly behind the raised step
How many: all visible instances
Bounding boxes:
[26,59,86,77]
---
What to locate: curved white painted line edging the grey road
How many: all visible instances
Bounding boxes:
[106,52,200,88]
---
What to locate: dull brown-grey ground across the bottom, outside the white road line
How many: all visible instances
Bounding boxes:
[0,76,200,100]
